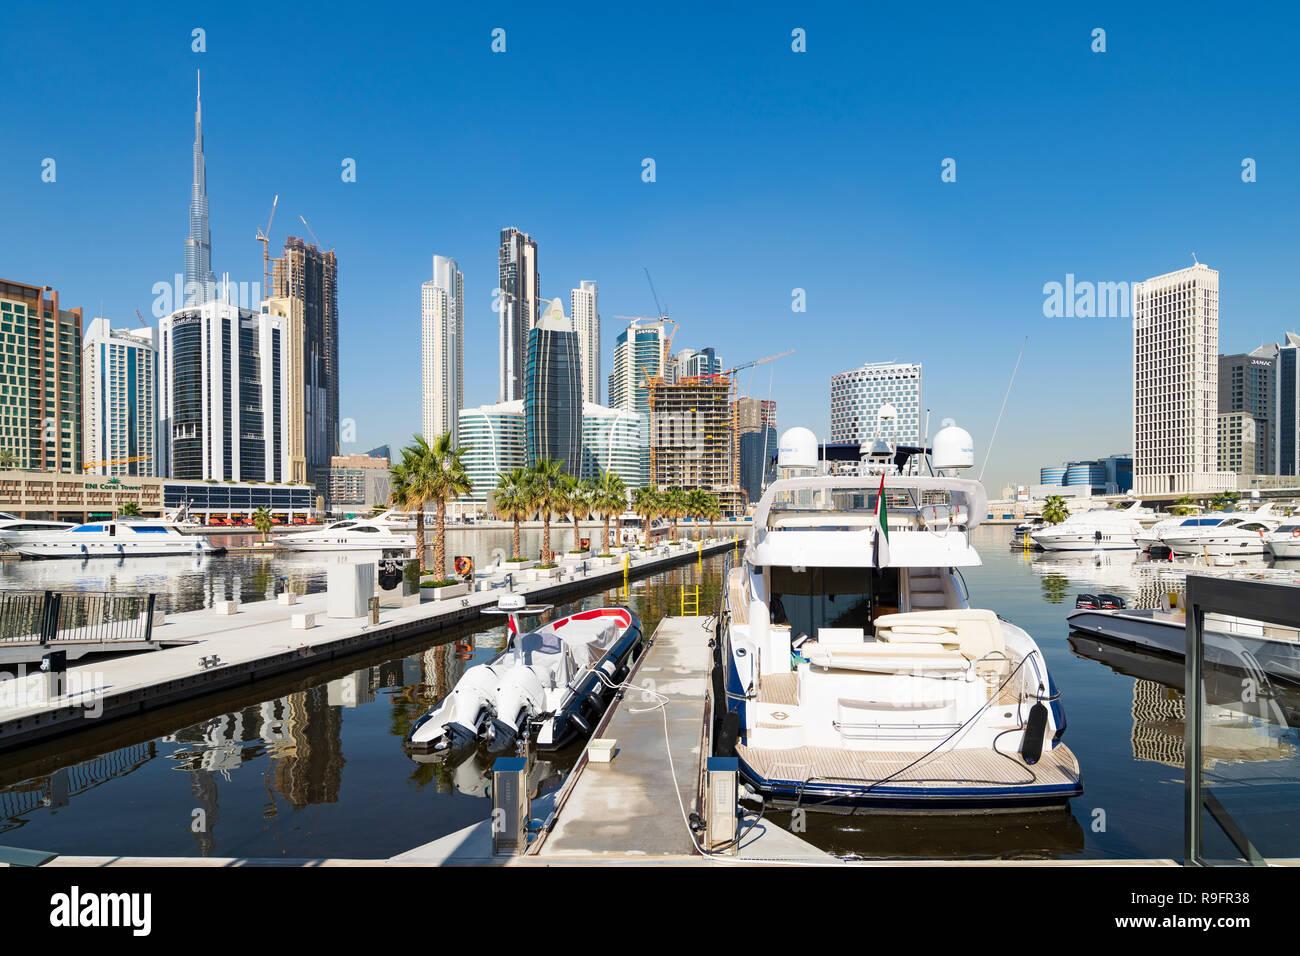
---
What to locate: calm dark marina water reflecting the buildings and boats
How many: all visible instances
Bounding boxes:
[0,527,1300,857]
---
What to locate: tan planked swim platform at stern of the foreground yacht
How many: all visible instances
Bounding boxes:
[736,738,1082,796]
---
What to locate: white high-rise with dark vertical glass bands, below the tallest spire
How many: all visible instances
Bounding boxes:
[159,299,292,481]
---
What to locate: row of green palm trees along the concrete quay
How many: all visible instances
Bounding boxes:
[389,433,723,579]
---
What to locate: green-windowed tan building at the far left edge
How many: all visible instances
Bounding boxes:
[0,280,82,475]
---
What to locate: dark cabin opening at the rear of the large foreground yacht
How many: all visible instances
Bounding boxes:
[770,567,898,637]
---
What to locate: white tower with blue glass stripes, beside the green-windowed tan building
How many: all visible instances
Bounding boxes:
[82,319,160,477]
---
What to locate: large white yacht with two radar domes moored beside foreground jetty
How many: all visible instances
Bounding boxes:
[714,423,1083,813]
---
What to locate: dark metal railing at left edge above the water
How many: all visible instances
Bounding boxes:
[0,591,157,645]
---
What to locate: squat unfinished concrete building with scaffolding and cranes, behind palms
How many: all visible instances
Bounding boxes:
[647,375,744,515]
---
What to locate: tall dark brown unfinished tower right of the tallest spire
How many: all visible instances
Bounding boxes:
[272,235,339,483]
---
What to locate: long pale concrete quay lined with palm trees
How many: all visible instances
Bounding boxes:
[0,538,736,752]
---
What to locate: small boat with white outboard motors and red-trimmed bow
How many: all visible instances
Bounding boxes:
[406,594,642,762]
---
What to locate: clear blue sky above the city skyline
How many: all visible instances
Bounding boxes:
[0,3,1300,494]
